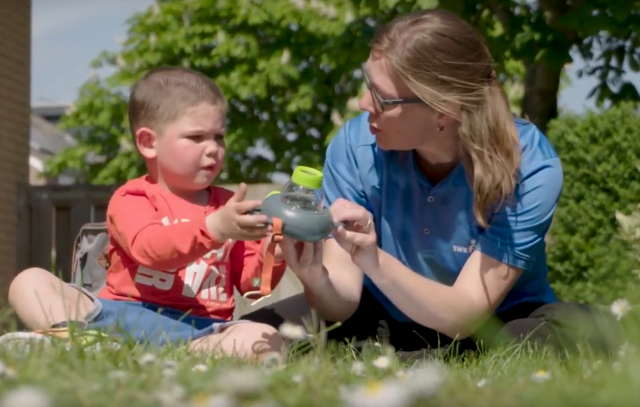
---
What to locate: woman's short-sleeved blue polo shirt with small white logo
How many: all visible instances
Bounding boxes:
[323,113,563,322]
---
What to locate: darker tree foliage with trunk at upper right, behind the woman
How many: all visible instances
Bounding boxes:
[442,0,640,131]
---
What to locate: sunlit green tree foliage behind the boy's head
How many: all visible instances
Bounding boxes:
[50,0,372,183]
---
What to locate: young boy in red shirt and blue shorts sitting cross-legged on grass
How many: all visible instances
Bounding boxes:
[4,67,286,364]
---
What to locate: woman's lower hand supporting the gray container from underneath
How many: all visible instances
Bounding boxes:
[278,236,328,285]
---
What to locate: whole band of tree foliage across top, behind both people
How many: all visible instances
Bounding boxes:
[48,0,640,183]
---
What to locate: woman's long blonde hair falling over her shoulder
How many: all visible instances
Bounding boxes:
[372,9,520,228]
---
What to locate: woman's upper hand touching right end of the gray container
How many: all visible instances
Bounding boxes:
[329,198,379,273]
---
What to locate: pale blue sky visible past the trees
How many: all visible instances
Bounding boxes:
[31,0,640,112]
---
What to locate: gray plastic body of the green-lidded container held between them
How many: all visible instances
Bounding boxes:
[255,194,334,242]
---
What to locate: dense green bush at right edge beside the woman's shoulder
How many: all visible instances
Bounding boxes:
[547,104,640,304]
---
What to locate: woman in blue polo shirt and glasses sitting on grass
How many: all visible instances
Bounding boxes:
[245,9,609,352]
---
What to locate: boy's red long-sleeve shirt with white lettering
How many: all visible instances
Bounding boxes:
[99,176,286,320]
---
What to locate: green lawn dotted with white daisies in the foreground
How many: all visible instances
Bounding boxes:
[0,306,640,407]
